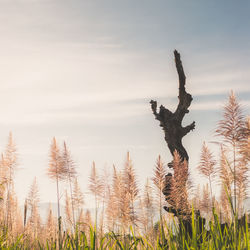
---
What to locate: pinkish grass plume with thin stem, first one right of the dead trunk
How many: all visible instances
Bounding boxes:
[198,142,216,207]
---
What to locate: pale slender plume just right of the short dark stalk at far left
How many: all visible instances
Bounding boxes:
[27,177,41,240]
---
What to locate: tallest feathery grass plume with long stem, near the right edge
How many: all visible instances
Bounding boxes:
[215,91,245,212]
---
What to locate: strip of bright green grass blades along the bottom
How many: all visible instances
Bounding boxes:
[0,213,250,250]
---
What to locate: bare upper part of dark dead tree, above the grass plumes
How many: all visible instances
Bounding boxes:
[150,50,195,161]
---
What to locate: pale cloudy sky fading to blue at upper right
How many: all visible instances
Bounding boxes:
[0,0,250,206]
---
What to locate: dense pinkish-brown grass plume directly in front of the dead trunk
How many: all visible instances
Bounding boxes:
[170,150,191,218]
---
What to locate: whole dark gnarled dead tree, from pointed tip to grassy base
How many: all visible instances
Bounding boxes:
[150,50,204,234]
